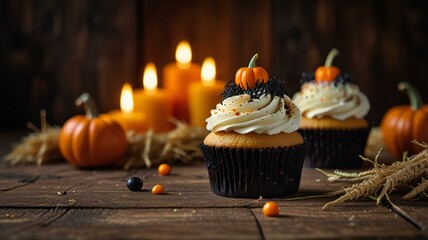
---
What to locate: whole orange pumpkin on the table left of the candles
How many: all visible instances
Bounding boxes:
[59,93,128,168]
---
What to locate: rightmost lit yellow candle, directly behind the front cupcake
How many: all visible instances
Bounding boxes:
[189,58,224,127]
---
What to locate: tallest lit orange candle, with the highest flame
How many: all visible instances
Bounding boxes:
[163,41,201,123]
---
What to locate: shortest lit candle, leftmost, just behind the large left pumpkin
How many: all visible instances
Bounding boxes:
[108,83,147,133]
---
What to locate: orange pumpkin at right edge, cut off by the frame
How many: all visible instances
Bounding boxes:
[380,82,428,157]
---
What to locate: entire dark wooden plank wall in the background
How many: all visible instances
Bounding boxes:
[0,0,428,129]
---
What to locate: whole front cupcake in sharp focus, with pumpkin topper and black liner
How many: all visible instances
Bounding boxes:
[201,54,307,198]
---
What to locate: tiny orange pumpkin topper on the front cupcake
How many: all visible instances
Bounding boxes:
[235,53,269,90]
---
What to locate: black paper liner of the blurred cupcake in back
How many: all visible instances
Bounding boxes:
[299,128,370,169]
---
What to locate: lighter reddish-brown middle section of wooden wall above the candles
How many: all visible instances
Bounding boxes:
[140,0,273,86]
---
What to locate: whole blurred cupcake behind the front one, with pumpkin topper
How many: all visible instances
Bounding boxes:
[293,49,370,169]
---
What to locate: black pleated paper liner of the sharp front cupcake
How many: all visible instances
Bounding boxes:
[200,143,307,198]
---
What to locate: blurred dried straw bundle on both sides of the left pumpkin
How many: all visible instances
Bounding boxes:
[4,114,208,170]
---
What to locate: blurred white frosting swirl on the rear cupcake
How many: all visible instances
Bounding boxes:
[293,81,370,120]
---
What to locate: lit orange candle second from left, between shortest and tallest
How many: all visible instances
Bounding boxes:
[134,63,173,133]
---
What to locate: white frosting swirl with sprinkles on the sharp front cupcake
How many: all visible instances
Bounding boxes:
[206,94,301,135]
